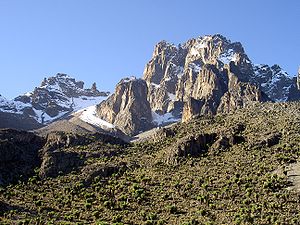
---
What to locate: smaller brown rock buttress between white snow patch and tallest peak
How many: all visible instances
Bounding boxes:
[97,78,152,135]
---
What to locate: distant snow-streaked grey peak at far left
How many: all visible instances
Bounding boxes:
[0,73,109,129]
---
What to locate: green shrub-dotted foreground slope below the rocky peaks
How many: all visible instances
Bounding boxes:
[0,102,300,224]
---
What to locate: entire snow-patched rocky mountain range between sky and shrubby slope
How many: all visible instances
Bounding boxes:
[0,34,300,138]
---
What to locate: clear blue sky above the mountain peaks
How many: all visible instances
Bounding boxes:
[0,0,300,98]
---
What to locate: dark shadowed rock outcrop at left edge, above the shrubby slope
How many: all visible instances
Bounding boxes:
[0,129,128,183]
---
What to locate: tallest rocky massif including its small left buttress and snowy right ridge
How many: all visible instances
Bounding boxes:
[97,35,300,134]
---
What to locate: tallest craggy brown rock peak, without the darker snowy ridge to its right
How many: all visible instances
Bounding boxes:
[143,35,270,124]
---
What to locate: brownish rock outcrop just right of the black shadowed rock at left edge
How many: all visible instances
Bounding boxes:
[39,132,127,178]
